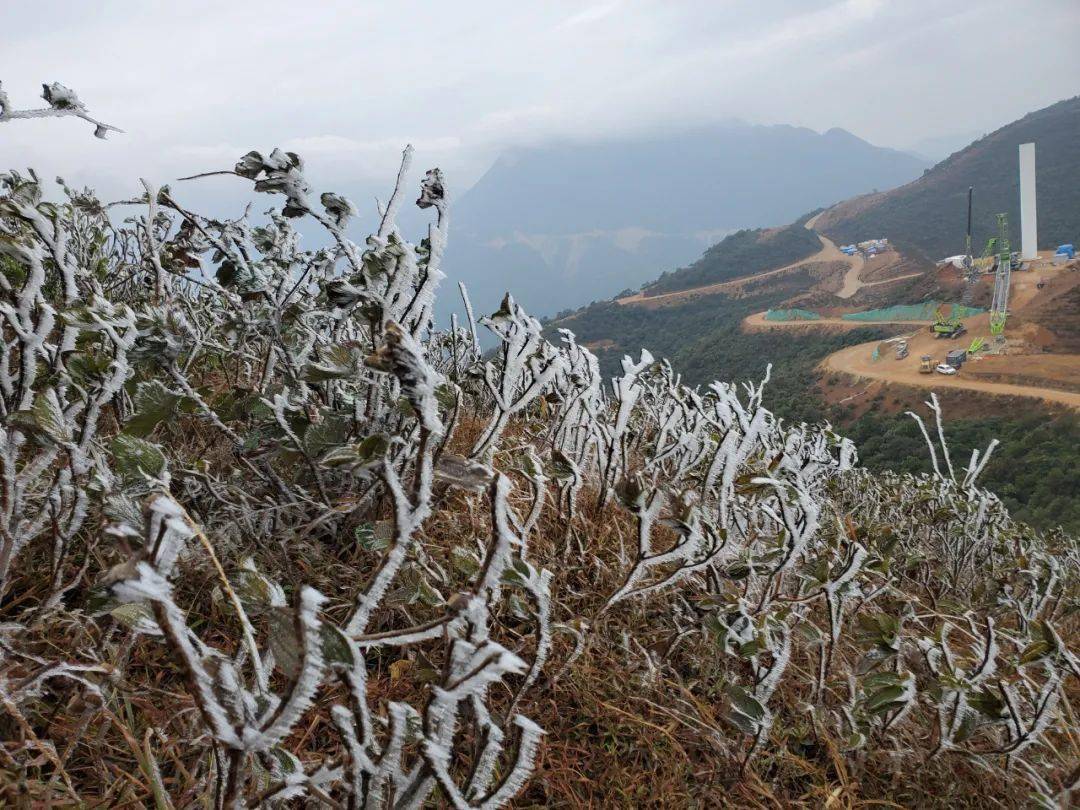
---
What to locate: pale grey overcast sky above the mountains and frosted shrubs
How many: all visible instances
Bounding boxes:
[0,0,1080,203]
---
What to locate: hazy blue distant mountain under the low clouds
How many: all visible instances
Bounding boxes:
[446,122,928,314]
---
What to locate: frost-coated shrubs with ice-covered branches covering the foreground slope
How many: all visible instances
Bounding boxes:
[0,87,1080,808]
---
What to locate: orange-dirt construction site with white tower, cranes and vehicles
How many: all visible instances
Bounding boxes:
[743,144,1080,408]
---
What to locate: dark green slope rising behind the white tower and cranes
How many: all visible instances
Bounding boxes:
[819,96,1080,260]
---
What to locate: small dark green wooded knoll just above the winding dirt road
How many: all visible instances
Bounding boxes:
[645,217,821,296]
